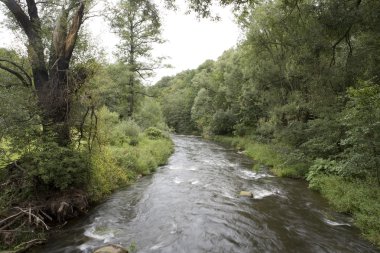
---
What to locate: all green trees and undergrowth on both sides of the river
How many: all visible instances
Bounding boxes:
[0,0,380,250]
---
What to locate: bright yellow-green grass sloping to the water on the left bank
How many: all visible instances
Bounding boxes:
[87,134,173,202]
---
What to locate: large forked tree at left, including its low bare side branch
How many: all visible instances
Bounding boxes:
[0,0,87,146]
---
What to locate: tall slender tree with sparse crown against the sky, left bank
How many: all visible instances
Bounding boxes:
[110,0,163,117]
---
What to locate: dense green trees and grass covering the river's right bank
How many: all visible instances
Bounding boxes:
[151,0,380,245]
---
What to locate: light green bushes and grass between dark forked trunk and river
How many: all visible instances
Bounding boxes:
[87,106,172,201]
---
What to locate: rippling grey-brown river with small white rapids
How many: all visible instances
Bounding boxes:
[36,136,380,253]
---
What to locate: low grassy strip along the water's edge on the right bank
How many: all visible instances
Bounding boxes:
[212,136,380,247]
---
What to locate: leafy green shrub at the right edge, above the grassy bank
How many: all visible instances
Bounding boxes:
[341,82,380,181]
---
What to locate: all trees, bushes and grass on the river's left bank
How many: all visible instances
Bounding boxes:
[0,0,173,252]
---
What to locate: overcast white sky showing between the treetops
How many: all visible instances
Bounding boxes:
[0,0,241,83]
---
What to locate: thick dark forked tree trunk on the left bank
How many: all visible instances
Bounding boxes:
[0,0,84,146]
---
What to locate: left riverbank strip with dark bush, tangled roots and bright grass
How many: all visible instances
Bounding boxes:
[0,128,173,252]
